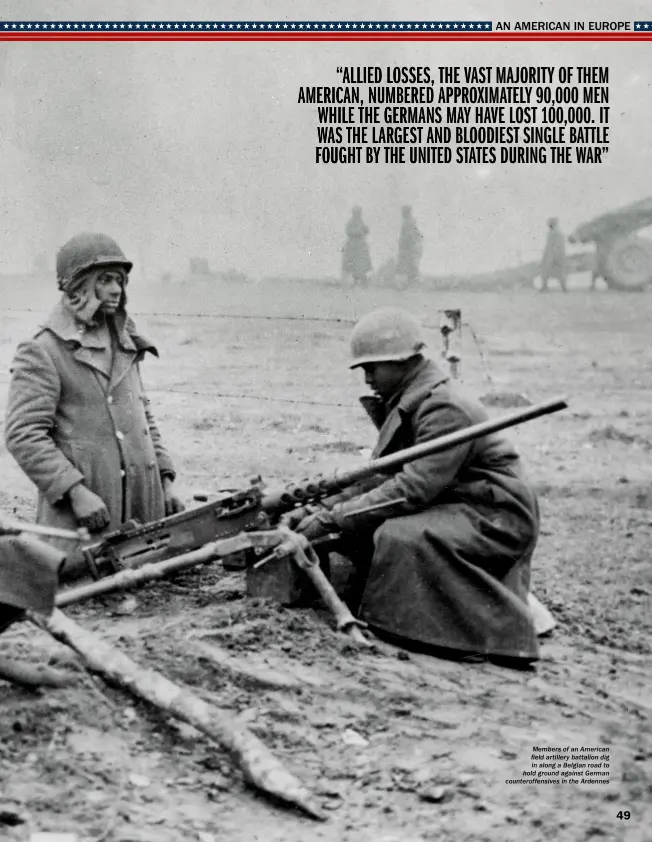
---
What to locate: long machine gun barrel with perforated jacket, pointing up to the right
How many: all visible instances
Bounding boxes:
[262,398,568,517]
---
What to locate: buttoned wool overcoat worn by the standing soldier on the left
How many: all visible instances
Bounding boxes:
[5,302,174,551]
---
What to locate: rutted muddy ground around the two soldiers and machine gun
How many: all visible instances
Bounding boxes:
[0,281,652,842]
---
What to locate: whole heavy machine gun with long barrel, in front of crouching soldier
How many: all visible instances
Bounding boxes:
[57,398,568,606]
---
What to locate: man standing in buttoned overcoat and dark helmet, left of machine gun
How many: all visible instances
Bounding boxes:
[5,233,183,572]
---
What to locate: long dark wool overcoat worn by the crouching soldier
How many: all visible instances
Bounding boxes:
[332,360,539,660]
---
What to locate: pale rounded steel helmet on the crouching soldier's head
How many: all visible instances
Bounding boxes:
[349,307,426,368]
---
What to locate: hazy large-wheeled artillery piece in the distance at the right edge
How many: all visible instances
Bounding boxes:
[568,197,652,291]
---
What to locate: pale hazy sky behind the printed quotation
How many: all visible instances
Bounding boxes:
[0,0,652,275]
